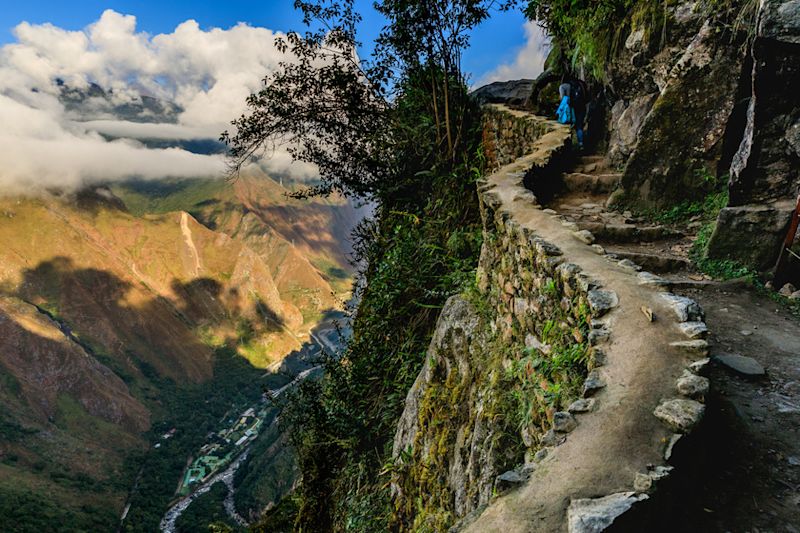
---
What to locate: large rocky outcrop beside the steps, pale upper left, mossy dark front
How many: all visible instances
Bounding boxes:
[609,8,743,207]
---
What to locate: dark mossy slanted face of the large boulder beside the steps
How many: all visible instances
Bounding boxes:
[617,20,742,208]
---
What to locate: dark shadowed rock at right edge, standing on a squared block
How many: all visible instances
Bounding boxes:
[708,0,800,270]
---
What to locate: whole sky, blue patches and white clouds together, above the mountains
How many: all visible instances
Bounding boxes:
[0,0,546,190]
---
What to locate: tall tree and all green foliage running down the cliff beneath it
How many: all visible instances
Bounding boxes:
[231,0,508,532]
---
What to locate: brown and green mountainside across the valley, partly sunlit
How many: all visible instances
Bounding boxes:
[0,176,357,531]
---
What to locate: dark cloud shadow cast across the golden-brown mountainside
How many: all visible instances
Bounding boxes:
[11,256,285,382]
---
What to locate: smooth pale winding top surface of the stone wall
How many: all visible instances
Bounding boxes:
[464,112,705,533]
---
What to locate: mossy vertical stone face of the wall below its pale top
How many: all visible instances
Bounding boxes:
[393,107,596,531]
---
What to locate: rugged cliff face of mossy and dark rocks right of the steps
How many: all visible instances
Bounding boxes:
[606,0,800,271]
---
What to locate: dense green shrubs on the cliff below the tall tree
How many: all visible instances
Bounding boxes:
[282,160,480,531]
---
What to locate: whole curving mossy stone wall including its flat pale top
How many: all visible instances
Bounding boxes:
[391,107,708,532]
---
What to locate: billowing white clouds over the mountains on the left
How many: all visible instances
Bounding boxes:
[0,10,315,192]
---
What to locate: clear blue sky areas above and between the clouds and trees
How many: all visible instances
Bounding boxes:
[0,0,526,80]
